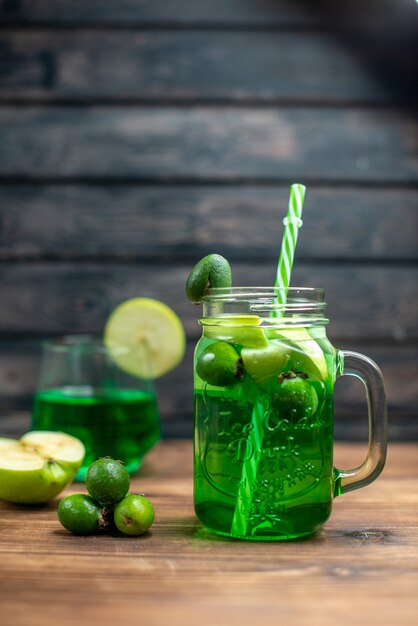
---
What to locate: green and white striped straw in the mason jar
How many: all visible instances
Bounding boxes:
[231,183,306,537]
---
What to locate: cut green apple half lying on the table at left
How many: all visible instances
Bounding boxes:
[0,430,85,504]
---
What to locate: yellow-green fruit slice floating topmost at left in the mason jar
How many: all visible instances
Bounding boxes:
[201,315,268,349]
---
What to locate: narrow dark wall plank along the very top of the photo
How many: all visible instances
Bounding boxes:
[0,0,414,30]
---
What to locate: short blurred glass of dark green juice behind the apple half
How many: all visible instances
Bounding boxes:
[32,335,160,480]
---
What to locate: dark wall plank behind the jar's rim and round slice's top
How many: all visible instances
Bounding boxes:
[0,260,418,341]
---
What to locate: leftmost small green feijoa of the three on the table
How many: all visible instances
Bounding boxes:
[58,493,107,535]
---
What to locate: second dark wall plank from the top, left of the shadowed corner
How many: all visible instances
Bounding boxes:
[0,30,390,103]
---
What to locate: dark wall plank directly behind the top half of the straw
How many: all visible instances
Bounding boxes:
[0,183,418,260]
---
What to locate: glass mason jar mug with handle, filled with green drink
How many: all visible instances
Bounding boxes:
[194,287,387,540]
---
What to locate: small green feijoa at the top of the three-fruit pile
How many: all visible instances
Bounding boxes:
[85,457,131,506]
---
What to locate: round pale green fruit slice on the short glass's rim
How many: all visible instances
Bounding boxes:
[104,298,186,380]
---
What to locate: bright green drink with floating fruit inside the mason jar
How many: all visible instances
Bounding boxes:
[195,321,334,539]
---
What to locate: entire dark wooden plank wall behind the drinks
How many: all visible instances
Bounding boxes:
[0,0,418,439]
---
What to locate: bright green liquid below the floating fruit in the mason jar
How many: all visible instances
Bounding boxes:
[195,338,334,540]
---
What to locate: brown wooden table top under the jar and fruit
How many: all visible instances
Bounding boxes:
[0,441,418,626]
